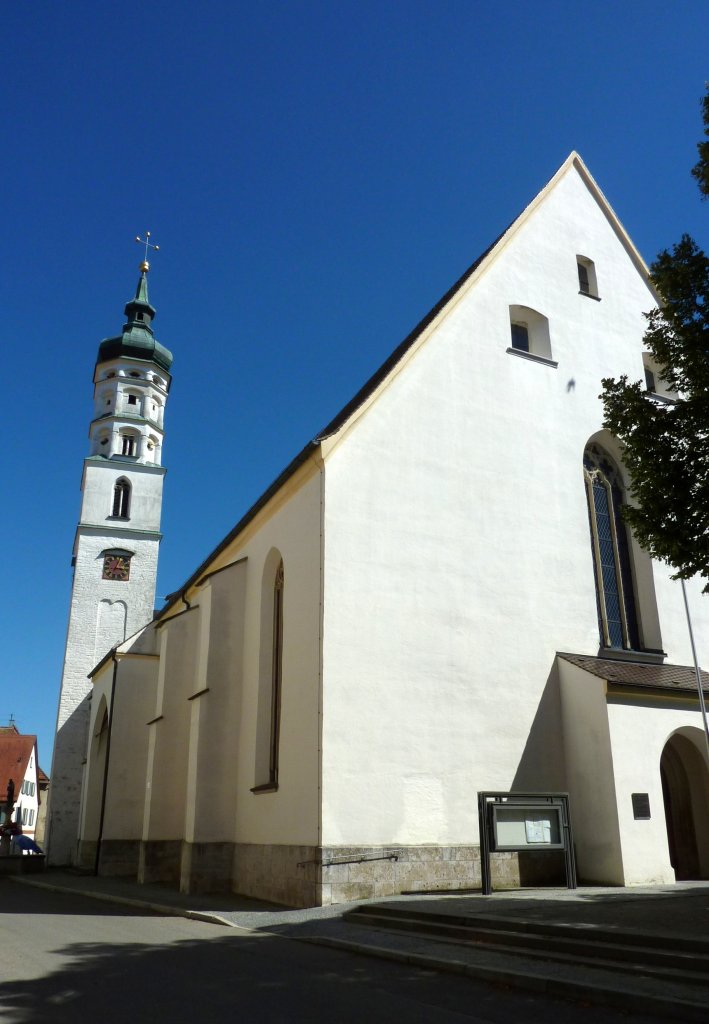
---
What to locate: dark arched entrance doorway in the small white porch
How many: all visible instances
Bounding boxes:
[660,729,709,882]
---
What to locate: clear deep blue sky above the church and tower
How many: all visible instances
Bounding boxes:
[0,0,709,770]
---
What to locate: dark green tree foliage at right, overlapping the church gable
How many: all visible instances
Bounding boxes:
[600,87,709,592]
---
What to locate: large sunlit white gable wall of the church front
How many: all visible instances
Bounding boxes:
[323,161,704,844]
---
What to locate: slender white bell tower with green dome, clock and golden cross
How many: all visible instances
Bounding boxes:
[47,245,172,865]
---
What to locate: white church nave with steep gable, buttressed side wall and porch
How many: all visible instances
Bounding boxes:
[66,154,709,905]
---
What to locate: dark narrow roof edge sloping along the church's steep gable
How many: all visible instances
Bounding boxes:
[156,152,653,618]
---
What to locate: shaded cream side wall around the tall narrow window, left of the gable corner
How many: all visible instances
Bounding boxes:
[165,466,321,845]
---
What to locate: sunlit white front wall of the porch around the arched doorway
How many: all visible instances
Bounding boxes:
[608,698,709,885]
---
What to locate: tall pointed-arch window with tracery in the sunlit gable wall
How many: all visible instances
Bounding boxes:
[583,444,639,650]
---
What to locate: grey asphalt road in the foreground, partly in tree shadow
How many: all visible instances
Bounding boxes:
[0,880,658,1024]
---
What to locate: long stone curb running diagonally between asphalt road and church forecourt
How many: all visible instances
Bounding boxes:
[8,876,709,1024]
